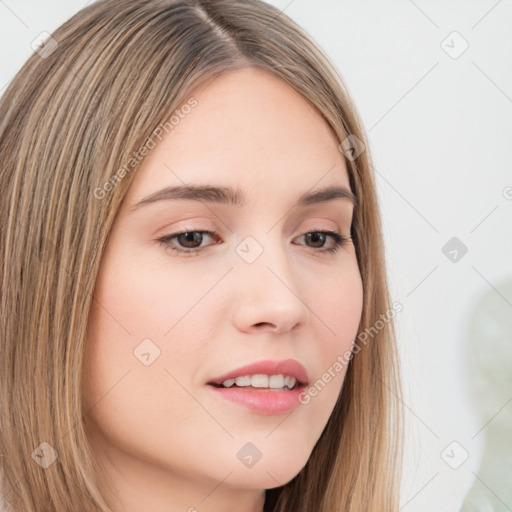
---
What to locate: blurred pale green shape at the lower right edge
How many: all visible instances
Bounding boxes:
[461,280,512,512]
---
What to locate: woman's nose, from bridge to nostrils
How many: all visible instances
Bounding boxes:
[233,241,310,334]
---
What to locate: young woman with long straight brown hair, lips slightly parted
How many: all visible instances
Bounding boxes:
[0,0,400,512]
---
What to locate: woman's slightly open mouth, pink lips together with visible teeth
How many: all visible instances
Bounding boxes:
[207,359,308,415]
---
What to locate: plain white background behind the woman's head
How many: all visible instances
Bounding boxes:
[0,0,512,512]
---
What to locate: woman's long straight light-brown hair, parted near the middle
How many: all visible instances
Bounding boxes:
[0,0,402,512]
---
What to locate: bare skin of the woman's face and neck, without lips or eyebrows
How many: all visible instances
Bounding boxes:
[83,68,363,512]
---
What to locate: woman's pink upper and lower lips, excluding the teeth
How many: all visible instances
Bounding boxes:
[208,359,308,415]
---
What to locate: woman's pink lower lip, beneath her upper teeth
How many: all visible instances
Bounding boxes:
[208,385,303,415]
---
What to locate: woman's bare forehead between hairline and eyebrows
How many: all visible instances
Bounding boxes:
[123,68,350,205]
